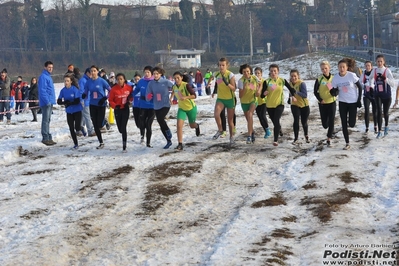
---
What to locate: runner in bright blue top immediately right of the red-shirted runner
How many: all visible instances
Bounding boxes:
[133,66,155,148]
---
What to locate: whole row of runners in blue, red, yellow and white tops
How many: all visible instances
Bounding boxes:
[52,55,398,152]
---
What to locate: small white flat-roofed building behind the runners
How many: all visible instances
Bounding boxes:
[155,49,205,68]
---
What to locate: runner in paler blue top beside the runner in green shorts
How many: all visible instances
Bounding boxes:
[146,67,173,149]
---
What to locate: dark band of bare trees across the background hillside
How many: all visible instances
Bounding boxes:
[0,0,396,78]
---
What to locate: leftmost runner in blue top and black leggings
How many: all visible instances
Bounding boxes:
[57,74,83,150]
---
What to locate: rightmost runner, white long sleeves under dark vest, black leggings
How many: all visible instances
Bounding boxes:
[370,54,396,138]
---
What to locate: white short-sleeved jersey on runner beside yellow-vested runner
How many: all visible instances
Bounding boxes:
[332,71,359,103]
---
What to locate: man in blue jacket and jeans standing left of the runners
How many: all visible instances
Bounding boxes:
[38,61,57,146]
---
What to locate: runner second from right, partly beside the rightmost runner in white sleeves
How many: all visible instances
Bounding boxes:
[360,61,378,134]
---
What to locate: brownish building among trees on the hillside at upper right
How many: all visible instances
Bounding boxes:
[308,24,349,48]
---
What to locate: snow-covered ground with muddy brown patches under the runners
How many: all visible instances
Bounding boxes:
[0,54,399,266]
